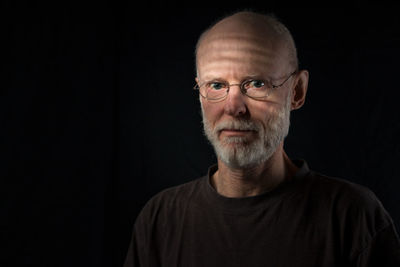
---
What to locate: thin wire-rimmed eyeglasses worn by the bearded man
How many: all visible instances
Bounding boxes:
[193,70,297,102]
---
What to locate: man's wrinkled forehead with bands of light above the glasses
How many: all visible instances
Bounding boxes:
[197,32,285,79]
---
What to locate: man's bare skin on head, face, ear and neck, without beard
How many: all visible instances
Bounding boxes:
[196,12,308,198]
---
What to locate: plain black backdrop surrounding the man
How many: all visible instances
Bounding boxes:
[0,1,400,266]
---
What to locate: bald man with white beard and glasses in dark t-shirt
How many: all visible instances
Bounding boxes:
[125,12,400,267]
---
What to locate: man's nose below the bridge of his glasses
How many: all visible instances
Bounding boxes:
[224,84,247,117]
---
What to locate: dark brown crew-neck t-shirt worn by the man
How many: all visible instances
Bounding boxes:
[124,161,400,267]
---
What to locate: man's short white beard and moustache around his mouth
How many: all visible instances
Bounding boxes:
[201,93,291,169]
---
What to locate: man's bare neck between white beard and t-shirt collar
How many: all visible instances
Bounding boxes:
[211,144,297,198]
